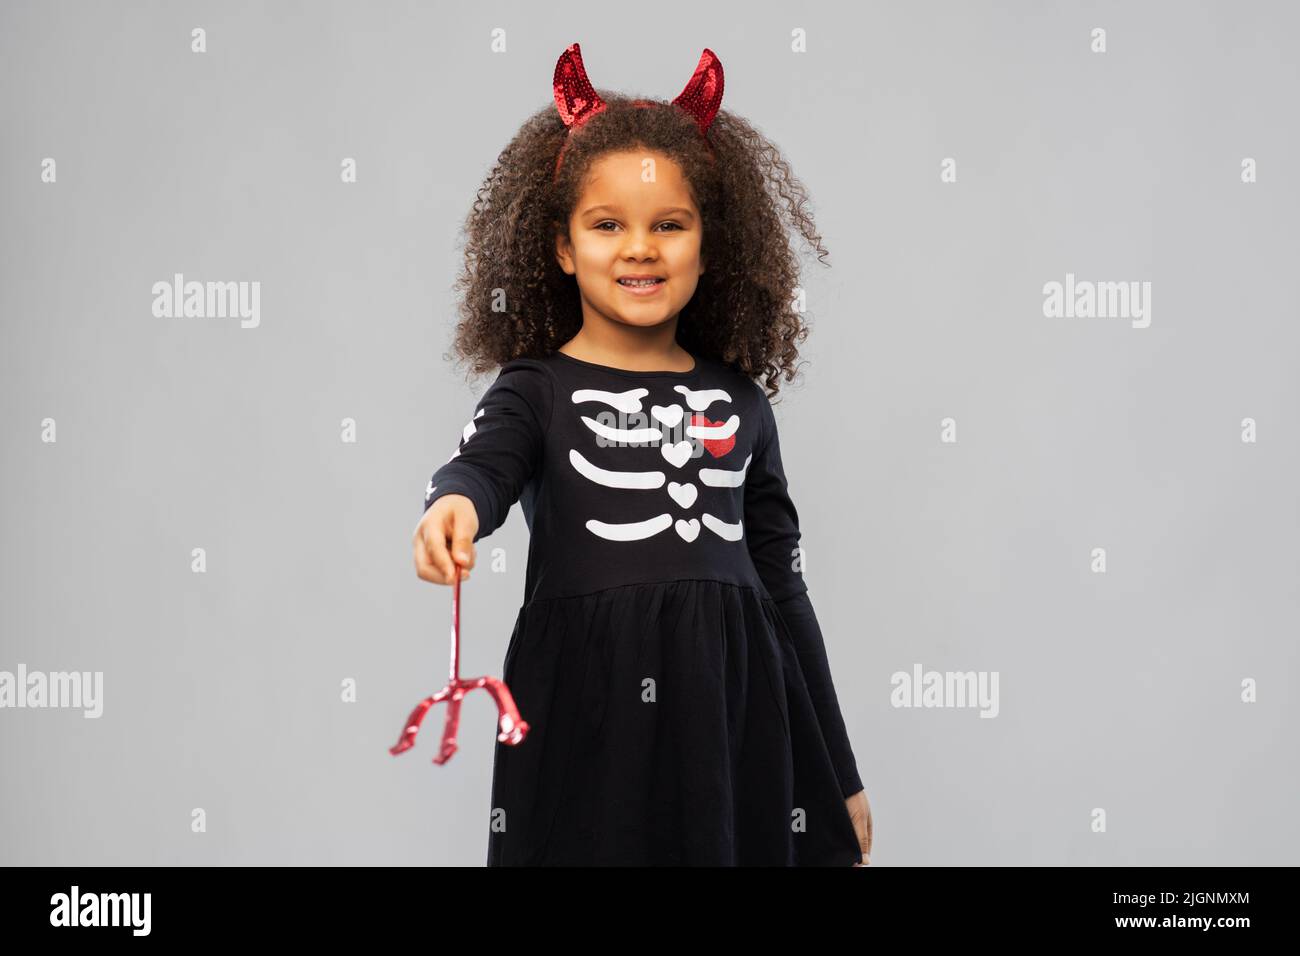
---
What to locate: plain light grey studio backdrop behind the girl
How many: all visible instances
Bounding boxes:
[0,0,1300,866]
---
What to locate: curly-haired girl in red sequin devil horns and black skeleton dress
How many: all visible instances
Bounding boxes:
[415,43,872,866]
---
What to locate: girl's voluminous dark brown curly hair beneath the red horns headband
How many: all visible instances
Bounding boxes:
[446,90,828,398]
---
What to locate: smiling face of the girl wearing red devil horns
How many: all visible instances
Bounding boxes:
[555,151,705,326]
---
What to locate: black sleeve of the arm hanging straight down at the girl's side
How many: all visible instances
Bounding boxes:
[745,384,863,797]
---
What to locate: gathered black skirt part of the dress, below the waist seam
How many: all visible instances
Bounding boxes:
[488,580,862,866]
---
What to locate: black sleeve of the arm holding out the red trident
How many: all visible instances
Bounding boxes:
[424,359,555,541]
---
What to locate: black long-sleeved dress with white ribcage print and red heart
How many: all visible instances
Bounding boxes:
[424,352,862,866]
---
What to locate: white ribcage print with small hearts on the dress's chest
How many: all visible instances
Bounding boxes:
[569,385,754,542]
